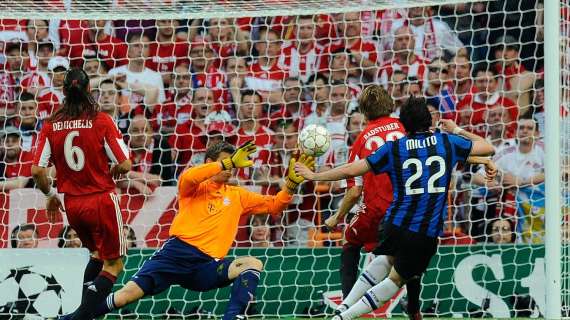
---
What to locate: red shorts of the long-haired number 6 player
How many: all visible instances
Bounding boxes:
[64,192,127,260]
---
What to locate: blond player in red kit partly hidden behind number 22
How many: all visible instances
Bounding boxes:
[325,85,420,318]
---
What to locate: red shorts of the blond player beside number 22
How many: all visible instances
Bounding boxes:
[344,211,382,252]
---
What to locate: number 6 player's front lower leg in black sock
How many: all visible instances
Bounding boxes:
[71,257,123,320]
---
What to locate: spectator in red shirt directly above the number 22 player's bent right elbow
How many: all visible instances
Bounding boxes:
[457,66,519,137]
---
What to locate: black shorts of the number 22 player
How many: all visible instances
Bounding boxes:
[373,223,438,281]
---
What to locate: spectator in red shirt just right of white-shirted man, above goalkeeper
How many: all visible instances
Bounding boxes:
[146,19,188,88]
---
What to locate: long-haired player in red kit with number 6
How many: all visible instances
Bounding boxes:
[32,69,131,320]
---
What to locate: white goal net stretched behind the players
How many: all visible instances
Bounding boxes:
[0,0,560,318]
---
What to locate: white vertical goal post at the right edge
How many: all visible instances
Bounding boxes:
[544,1,560,319]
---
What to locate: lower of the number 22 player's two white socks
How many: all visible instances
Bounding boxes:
[340,278,400,320]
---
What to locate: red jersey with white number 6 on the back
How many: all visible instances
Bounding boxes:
[34,112,129,196]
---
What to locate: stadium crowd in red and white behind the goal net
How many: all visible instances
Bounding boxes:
[0,0,552,248]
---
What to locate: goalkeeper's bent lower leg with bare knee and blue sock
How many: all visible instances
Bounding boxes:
[223,257,263,320]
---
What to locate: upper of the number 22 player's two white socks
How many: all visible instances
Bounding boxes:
[342,256,392,307]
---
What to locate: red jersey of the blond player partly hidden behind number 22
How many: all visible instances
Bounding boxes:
[347,117,406,217]
